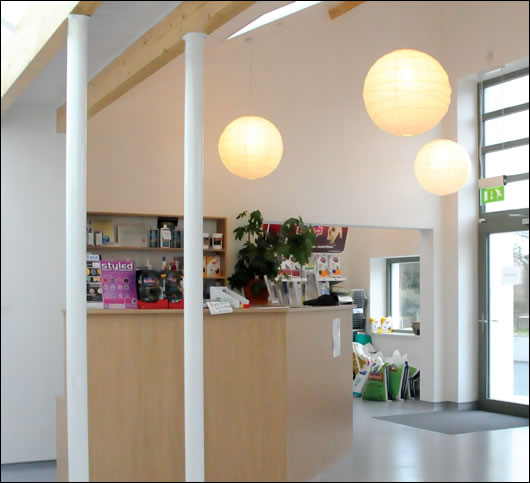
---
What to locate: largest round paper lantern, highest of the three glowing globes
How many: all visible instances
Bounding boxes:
[363,49,451,136]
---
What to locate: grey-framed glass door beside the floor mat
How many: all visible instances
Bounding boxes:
[479,213,529,416]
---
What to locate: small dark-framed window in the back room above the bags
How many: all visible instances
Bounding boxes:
[386,257,420,332]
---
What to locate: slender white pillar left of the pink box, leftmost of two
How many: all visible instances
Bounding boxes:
[66,15,89,481]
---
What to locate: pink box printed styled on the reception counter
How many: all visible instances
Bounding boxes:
[101,260,138,309]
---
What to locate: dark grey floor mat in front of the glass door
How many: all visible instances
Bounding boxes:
[374,410,528,434]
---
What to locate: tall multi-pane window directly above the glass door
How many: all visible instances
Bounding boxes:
[478,68,528,214]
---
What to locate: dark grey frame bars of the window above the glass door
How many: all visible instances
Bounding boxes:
[477,67,529,220]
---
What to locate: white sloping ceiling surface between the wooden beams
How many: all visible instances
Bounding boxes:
[14,1,296,108]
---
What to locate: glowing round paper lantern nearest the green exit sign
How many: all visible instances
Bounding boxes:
[414,139,471,195]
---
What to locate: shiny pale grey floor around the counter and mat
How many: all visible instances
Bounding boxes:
[1,399,529,482]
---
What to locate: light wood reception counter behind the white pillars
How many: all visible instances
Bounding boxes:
[58,306,352,481]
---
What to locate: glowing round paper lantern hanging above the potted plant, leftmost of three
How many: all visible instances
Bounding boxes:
[218,116,283,179]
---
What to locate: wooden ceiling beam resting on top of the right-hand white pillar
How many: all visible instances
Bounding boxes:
[57,1,255,132]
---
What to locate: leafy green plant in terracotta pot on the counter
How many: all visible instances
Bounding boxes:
[228,210,316,305]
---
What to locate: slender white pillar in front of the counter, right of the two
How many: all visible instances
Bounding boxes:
[184,32,206,481]
